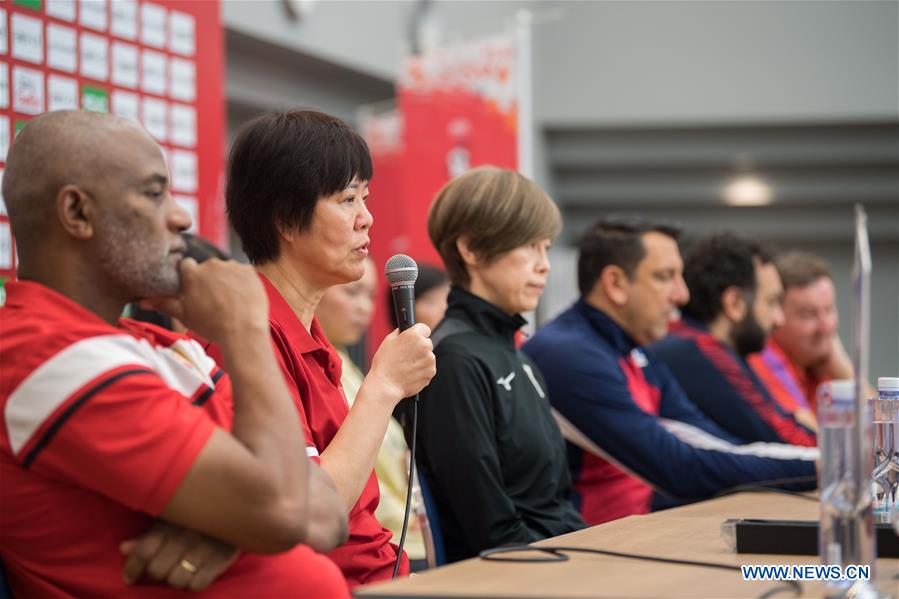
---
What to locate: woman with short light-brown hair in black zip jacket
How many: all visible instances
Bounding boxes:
[406,167,584,562]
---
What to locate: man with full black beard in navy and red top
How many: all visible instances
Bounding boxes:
[651,233,817,447]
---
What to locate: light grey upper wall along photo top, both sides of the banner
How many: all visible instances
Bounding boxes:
[223,0,899,125]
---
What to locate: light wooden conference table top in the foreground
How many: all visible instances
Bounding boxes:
[355,493,899,599]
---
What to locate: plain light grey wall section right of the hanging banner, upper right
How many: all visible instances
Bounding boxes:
[534,1,899,125]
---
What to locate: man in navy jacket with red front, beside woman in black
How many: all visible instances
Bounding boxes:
[524,220,817,524]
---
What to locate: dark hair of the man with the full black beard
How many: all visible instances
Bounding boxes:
[682,233,771,323]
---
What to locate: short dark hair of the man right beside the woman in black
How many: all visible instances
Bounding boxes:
[577,216,680,296]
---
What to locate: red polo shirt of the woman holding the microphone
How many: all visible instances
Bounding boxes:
[207,274,409,587]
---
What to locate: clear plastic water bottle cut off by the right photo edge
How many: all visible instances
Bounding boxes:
[871,377,899,524]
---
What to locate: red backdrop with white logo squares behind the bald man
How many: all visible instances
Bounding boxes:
[0,0,227,294]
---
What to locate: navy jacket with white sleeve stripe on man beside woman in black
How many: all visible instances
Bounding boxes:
[523,300,815,523]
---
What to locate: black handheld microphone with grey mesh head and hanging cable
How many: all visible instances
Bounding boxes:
[384,254,418,578]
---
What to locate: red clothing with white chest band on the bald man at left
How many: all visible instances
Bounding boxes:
[0,281,347,598]
